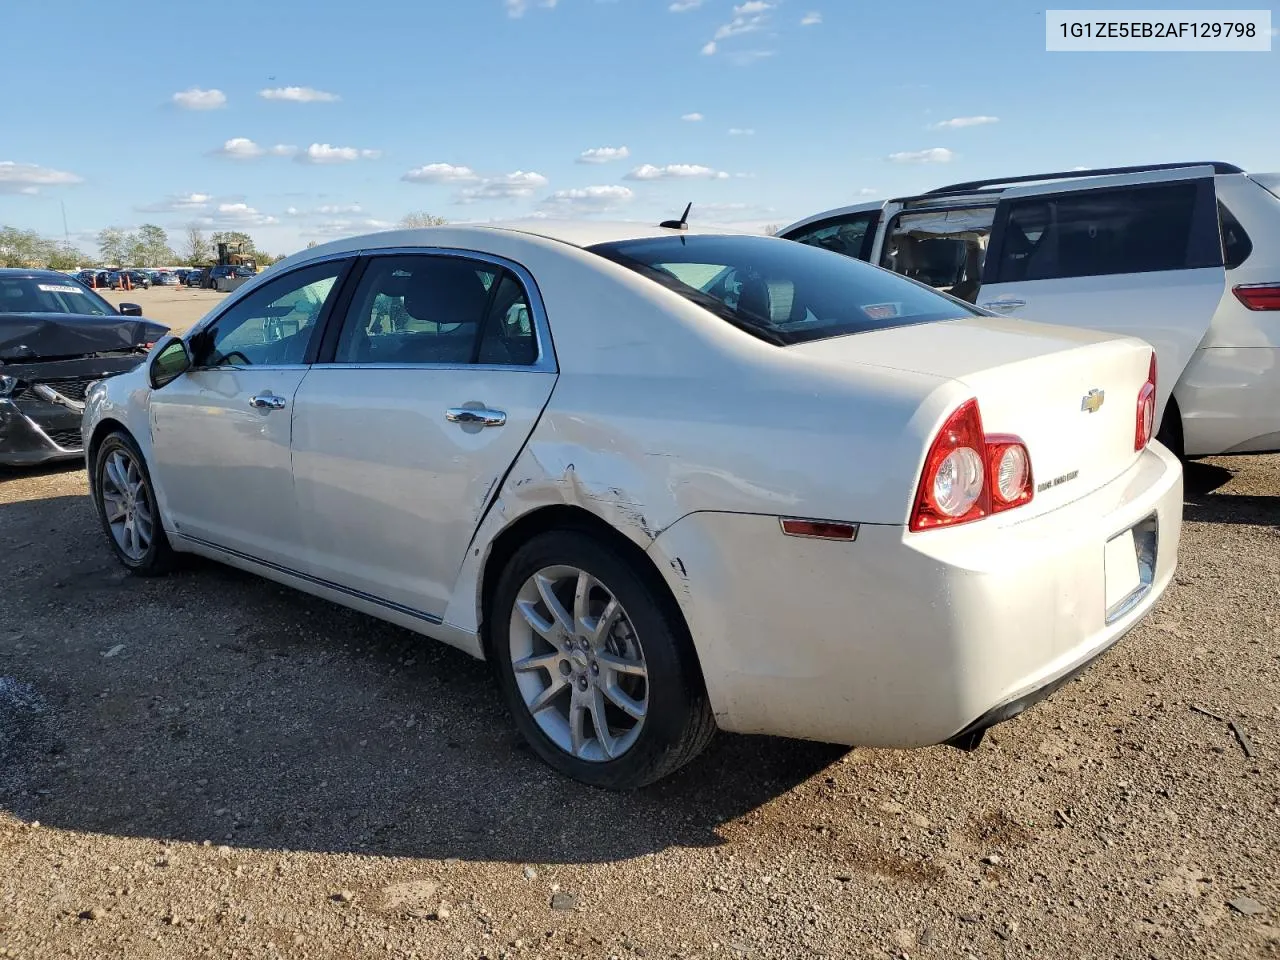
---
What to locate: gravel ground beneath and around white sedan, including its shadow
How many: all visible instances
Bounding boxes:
[0,457,1280,960]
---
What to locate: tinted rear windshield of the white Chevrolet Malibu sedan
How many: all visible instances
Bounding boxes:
[589,236,977,346]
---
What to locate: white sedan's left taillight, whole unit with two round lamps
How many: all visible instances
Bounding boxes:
[910,399,1034,530]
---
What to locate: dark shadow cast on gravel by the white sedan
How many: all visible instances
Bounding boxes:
[0,497,846,863]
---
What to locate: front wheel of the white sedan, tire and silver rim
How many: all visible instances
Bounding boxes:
[93,431,174,576]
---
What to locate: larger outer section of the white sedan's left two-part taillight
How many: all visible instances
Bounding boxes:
[911,399,991,530]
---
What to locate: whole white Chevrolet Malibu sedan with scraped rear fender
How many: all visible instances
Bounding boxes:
[83,223,1181,788]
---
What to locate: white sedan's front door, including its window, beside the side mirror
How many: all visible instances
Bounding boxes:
[148,259,351,566]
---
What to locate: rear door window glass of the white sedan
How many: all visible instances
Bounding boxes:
[334,253,538,366]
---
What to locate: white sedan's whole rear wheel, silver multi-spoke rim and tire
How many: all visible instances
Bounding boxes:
[489,531,716,790]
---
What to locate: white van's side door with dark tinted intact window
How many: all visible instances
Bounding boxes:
[978,166,1226,424]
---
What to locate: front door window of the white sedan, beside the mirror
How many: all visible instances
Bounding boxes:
[192,260,349,367]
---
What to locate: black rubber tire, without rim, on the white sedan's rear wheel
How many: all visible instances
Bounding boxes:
[486,530,716,790]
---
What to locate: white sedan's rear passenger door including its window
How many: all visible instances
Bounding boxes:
[293,252,556,620]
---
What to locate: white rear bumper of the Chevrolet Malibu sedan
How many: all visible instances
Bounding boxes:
[650,444,1181,748]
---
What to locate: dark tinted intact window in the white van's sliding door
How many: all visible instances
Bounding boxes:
[983,182,1222,283]
